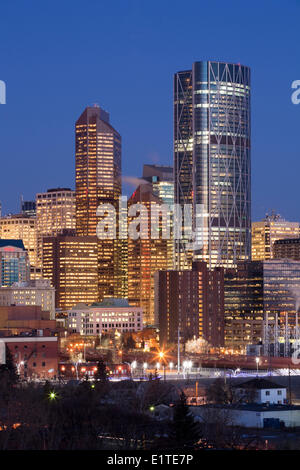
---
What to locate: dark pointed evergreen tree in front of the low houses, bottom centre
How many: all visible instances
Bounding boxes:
[170,392,200,447]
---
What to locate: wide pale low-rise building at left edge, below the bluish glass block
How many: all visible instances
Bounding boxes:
[0,279,55,320]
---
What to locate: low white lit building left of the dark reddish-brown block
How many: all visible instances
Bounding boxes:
[68,298,143,335]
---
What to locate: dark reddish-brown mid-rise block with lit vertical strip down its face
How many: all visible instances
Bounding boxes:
[155,261,224,347]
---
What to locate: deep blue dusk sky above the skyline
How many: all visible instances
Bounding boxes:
[0,0,300,220]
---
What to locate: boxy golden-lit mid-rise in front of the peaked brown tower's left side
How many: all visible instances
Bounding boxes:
[42,230,98,312]
